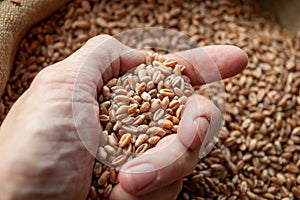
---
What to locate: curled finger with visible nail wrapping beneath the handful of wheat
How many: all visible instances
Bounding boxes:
[115,95,221,195]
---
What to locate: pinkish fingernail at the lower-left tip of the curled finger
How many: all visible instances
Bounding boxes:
[123,163,157,192]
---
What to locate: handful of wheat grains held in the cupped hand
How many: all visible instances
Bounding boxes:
[89,53,193,199]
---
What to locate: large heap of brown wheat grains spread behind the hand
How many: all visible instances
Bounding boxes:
[0,0,300,200]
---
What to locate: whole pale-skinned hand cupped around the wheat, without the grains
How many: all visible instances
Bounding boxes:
[0,35,247,200]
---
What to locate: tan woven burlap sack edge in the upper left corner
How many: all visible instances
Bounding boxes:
[0,0,69,97]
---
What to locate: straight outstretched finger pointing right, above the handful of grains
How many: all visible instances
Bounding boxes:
[167,45,248,85]
